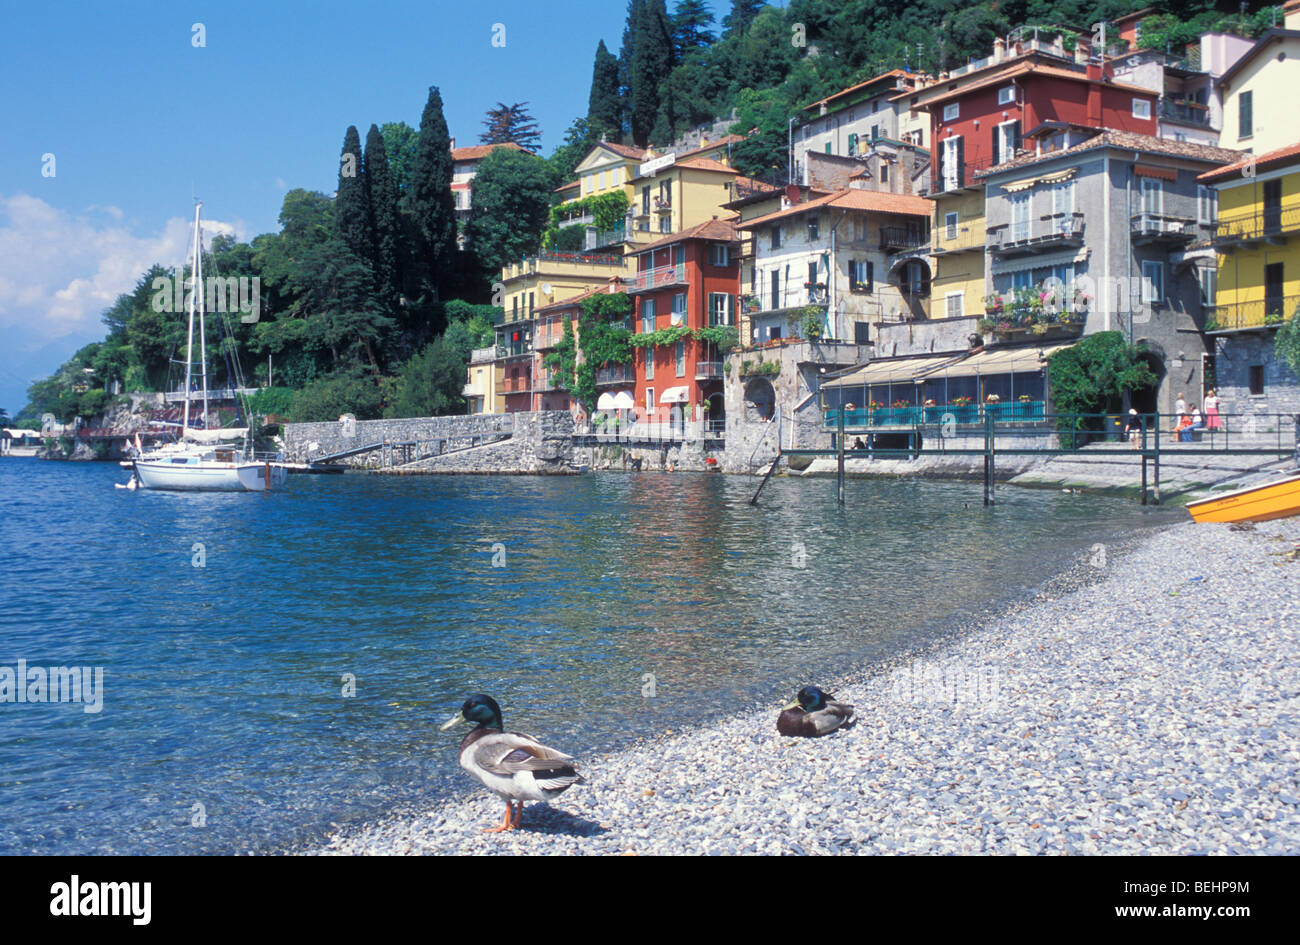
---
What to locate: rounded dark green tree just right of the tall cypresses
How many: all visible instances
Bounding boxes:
[465,148,555,273]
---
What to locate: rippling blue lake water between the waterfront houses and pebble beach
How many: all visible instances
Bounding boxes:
[0,459,1180,854]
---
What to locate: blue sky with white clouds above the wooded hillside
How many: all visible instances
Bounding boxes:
[0,0,650,413]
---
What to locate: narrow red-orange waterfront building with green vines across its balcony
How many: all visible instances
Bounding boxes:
[627,220,740,433]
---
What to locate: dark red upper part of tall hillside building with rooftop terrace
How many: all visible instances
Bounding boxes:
[898,39,1158,187]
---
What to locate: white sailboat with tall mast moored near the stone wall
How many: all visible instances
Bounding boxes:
[126,203,289,493]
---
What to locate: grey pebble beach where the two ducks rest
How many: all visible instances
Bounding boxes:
[321,519,1300,854]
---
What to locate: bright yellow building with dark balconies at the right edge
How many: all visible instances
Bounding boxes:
[1200,142,1300,331]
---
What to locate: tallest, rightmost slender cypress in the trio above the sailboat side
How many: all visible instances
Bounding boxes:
[404,86,456,308]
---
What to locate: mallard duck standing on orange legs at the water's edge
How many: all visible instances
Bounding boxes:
[442,693,582,833]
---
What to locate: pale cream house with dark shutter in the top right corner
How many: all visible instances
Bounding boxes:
[1218,27,1300,155]
